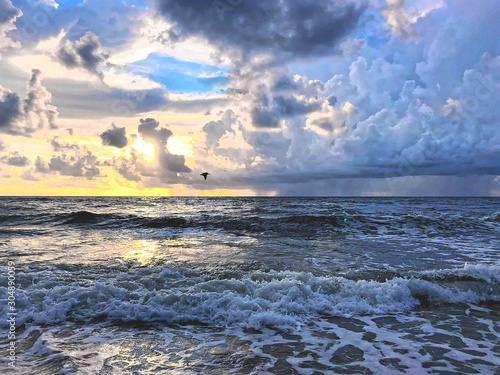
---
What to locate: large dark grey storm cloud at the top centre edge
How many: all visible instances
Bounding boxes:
[157,0,364,57]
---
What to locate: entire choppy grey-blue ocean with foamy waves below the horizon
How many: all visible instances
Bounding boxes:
[0,197,500,375]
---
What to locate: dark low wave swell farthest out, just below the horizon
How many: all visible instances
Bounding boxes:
[0,211,500,236]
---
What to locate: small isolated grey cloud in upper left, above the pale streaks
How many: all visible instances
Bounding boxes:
[56,31,108,79]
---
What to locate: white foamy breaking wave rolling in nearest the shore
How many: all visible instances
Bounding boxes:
[0,266,500,330]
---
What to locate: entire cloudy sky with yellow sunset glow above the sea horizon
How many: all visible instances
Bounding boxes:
[0,0,500,196]
